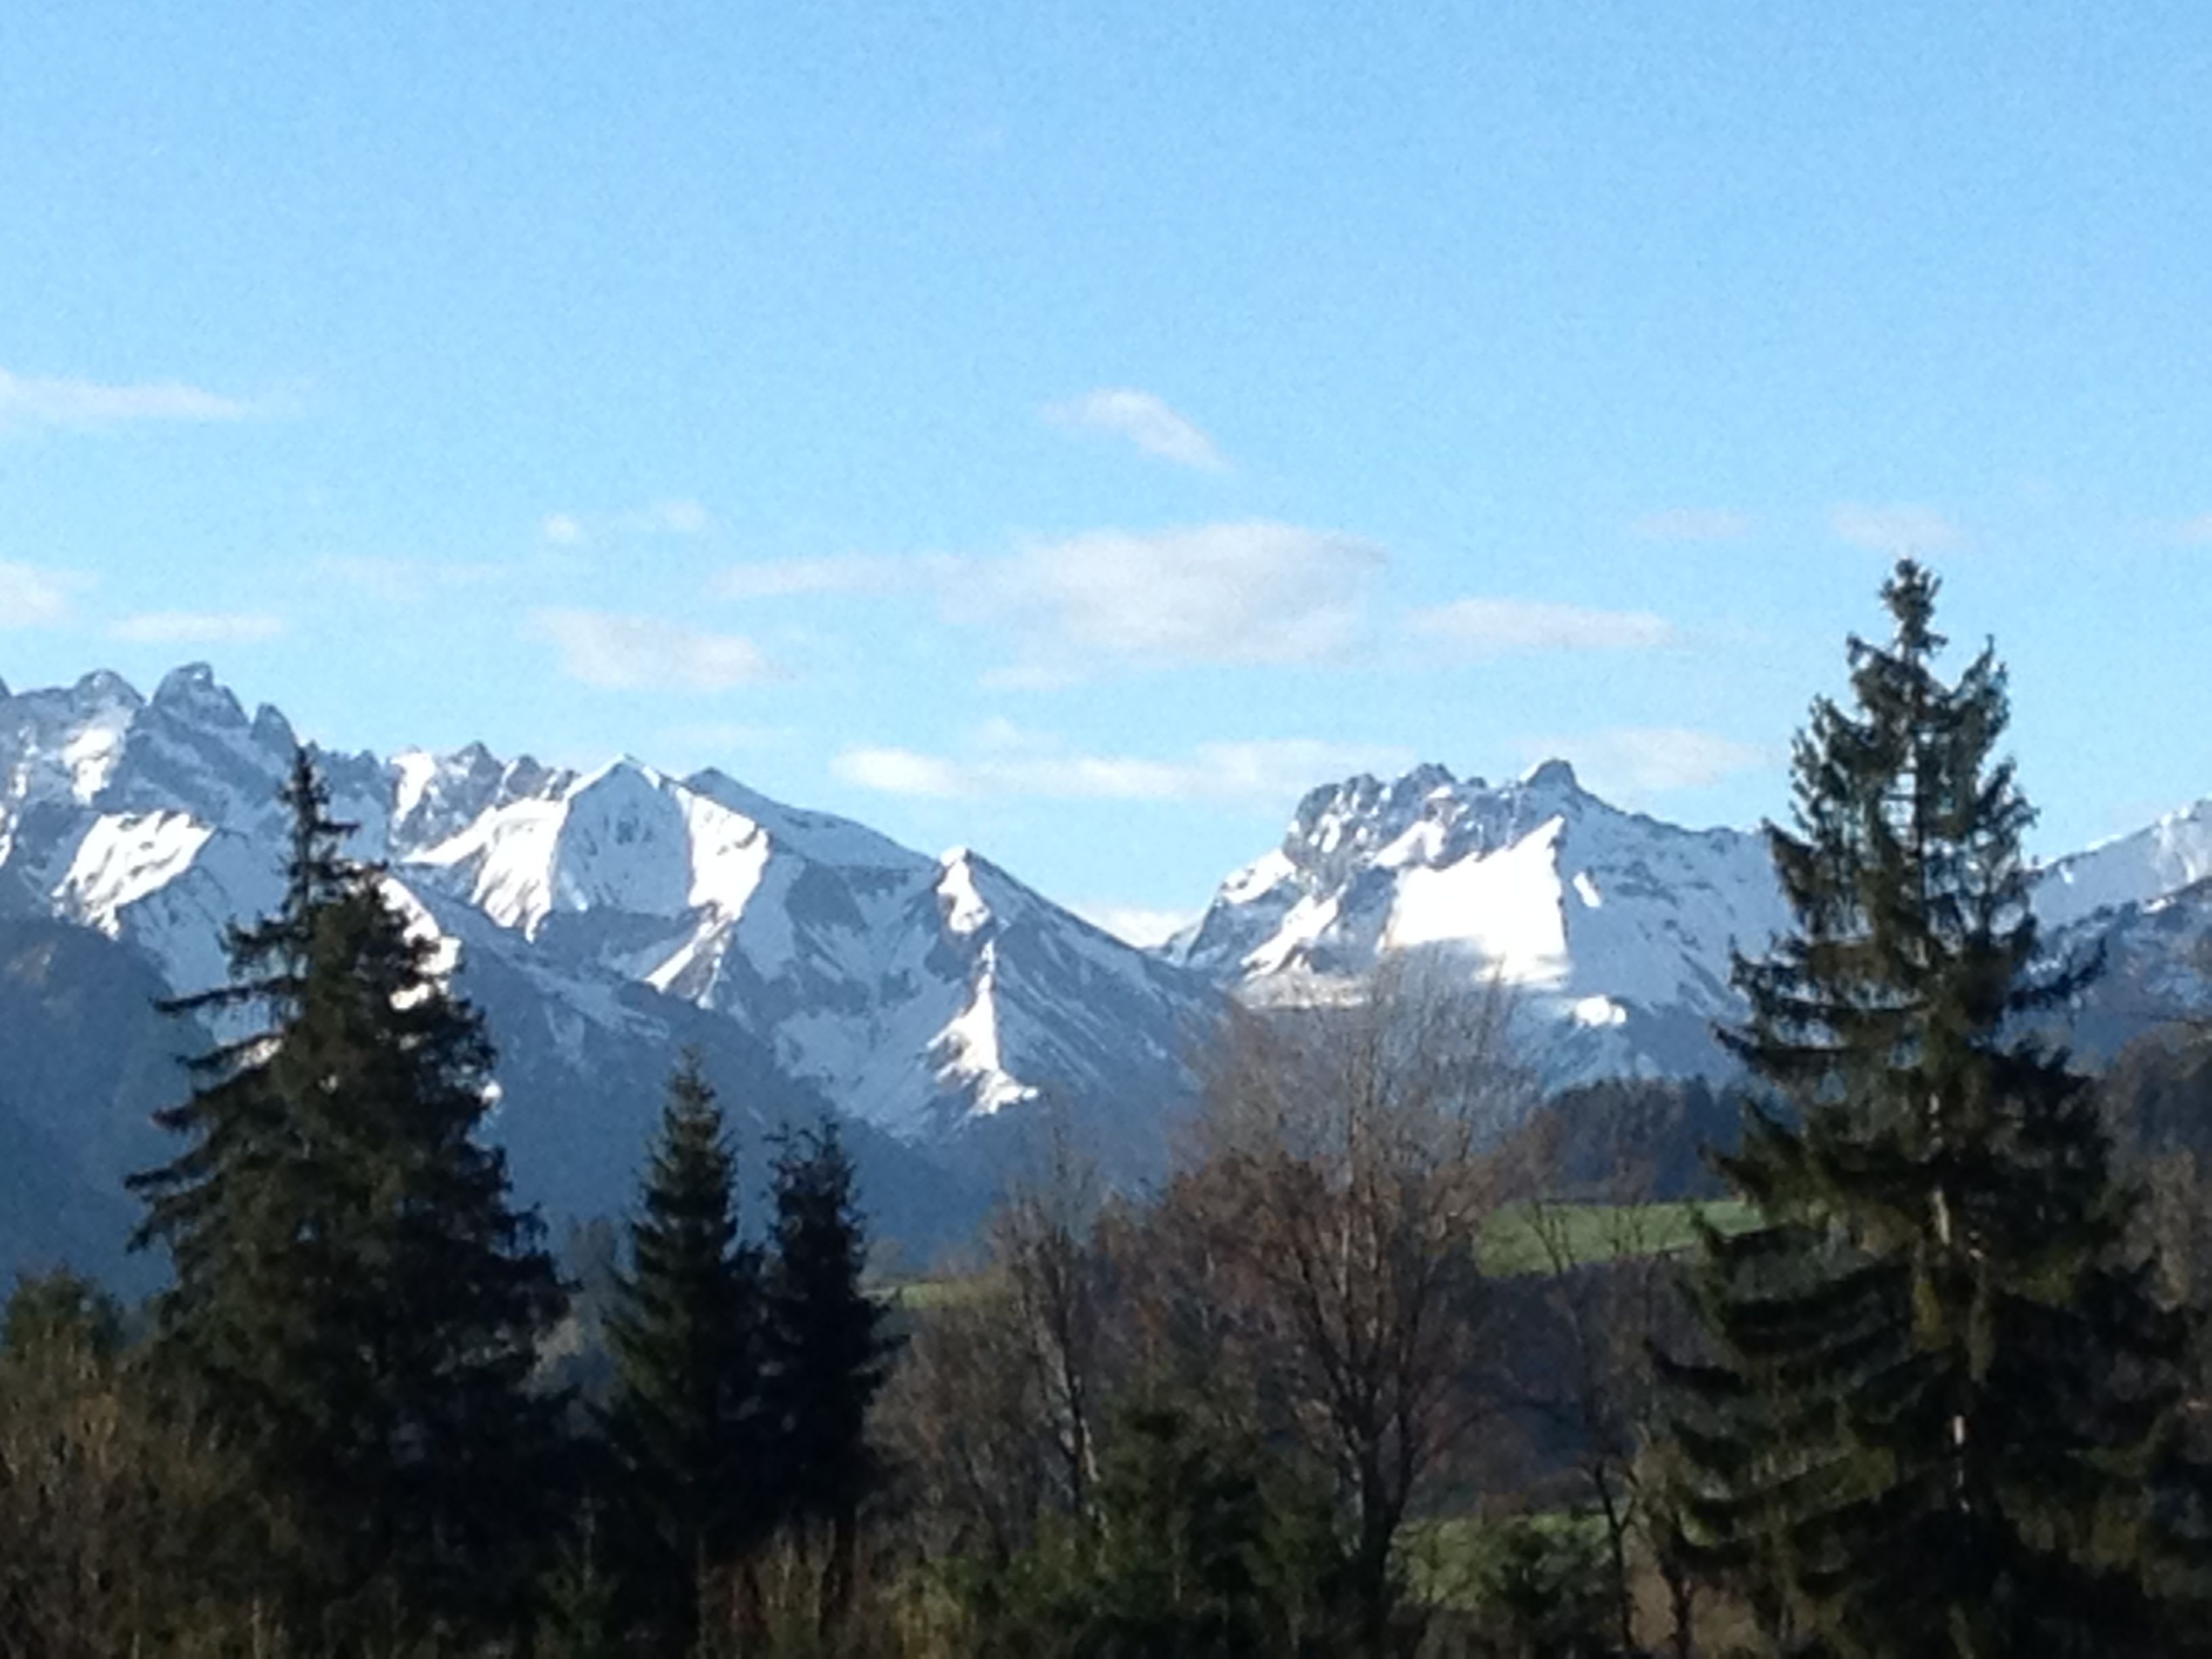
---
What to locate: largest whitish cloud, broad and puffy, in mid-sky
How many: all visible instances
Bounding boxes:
[968,522,1382,677]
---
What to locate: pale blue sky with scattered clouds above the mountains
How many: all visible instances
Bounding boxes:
[0,0,2212,937]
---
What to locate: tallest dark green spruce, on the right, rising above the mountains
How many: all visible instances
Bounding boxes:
[1666,560,2188,1657]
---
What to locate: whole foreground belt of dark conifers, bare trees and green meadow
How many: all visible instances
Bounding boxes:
[0,562,2212,1659]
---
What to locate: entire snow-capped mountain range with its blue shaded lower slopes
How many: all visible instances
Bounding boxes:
[0,665,2212,1283]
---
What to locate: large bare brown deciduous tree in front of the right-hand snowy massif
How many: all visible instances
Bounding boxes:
[1166,962,1526,1652]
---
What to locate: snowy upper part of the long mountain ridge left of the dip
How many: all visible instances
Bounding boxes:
[0,663,1214,1139]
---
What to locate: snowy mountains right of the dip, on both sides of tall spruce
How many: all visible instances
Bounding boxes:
[1162,761,2212,1086]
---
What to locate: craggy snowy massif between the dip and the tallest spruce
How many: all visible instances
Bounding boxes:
[1166,761,1785,1082]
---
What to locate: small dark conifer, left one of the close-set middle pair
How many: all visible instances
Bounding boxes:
[606,1053,768,1652]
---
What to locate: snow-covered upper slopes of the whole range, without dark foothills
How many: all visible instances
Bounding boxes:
[0,668,2212,1139]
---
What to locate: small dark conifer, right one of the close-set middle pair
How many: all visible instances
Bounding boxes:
[763,1120,896,1631]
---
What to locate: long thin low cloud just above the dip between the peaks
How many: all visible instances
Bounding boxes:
[832,739,1411,807]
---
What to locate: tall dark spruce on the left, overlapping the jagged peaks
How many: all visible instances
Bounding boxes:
[133,754,560,1652]
